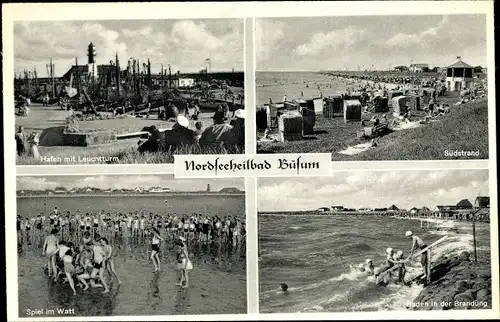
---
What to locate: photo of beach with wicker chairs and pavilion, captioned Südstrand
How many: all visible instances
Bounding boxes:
[255,14,492,161]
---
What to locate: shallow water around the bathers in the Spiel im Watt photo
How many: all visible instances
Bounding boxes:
[18,196,247,317]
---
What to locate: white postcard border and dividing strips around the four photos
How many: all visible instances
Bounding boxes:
[2,1,500,321]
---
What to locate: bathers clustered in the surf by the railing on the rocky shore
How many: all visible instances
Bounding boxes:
[358,231,430,285]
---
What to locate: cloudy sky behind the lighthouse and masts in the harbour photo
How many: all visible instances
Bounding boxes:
[14,19,244,77]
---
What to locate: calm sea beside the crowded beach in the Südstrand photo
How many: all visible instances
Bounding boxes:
[255,72,351,105]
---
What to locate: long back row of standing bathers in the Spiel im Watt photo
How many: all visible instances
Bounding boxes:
[17,207,246,250]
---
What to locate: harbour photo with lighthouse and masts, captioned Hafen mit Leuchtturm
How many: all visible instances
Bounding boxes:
[12,19,245,165]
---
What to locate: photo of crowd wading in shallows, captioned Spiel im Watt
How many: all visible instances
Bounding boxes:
[16,175,247,318]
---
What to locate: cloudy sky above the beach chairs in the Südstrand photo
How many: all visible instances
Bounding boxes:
[255,14,487,71]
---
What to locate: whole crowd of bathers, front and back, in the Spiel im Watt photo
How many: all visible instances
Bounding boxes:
[17,207,246,294]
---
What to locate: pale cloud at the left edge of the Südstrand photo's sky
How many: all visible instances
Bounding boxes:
[255,19,285,61]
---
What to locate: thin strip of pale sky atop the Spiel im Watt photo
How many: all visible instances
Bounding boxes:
[16,175,245,191]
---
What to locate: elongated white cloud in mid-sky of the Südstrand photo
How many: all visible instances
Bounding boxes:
[293,26,365,56]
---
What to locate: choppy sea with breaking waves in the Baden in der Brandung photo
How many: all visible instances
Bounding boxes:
[259,213,490,313]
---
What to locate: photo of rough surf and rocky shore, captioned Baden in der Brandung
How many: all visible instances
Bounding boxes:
[257,169,495,313]
